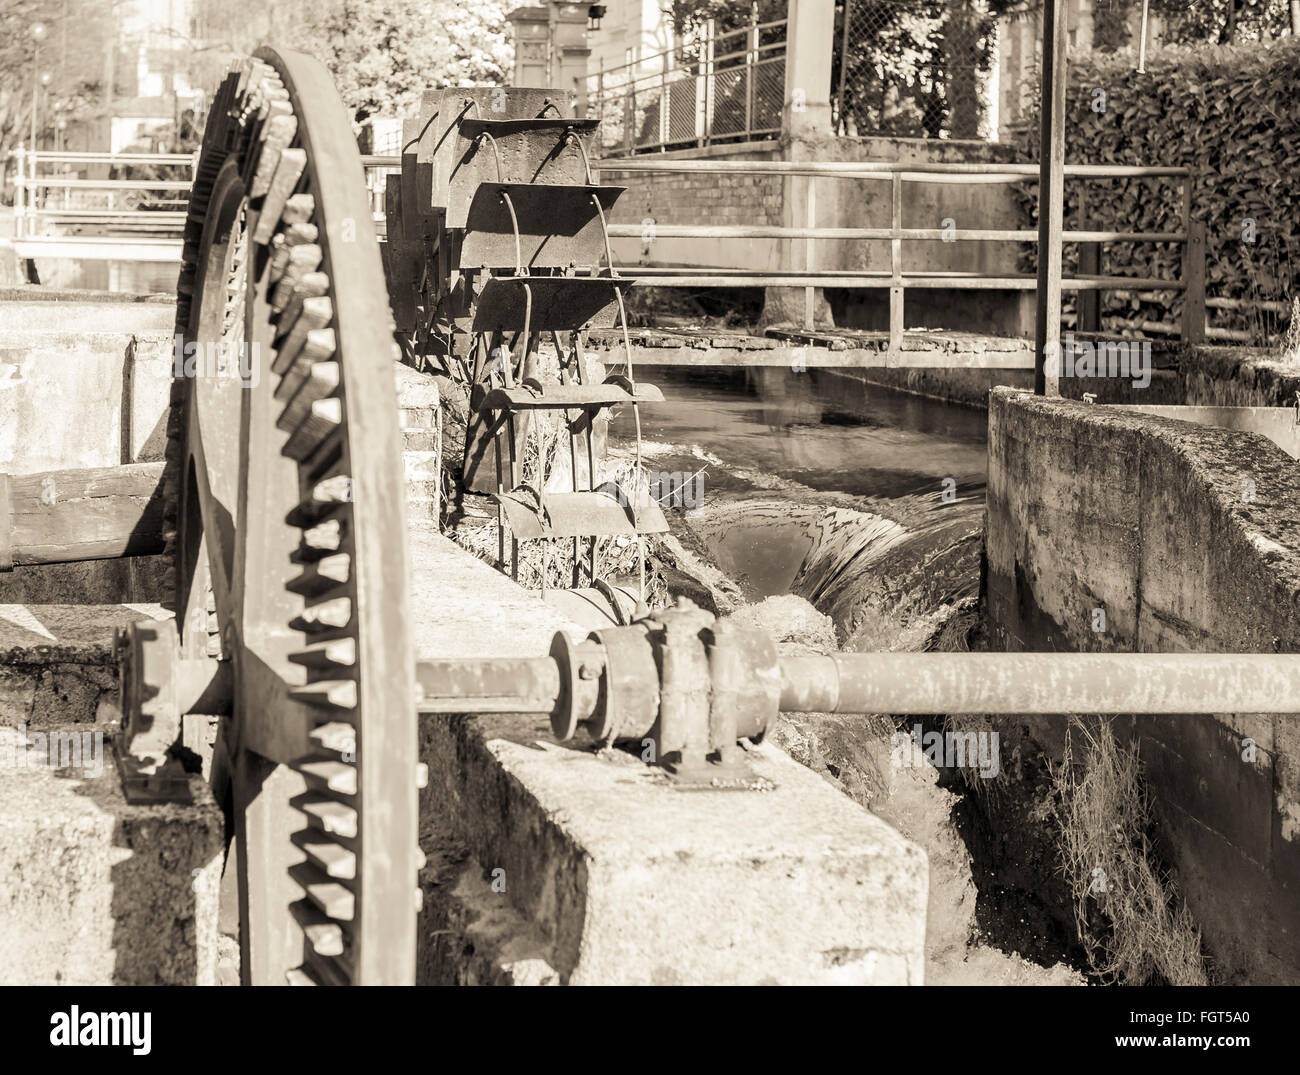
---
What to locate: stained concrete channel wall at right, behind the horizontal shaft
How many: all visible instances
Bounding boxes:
[984,390,1300,983]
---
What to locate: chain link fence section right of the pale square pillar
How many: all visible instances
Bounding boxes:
[831,0,997,140]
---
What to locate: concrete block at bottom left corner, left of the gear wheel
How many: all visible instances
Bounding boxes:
[0,725,224,985]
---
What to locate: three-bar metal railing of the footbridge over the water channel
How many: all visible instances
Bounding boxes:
[594,157,1205,350]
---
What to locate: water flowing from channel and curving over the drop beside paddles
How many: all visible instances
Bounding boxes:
[612,369,985,649]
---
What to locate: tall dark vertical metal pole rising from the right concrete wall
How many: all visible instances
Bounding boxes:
[1034,0,1067,395]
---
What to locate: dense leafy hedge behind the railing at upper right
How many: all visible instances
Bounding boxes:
[1021,36,1300,340]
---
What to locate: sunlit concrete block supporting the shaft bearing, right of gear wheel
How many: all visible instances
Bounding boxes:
[411,528,927,984]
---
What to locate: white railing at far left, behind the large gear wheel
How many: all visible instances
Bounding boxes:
[12,147,195,261]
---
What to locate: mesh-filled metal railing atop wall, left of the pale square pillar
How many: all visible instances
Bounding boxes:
[586,19,785,155]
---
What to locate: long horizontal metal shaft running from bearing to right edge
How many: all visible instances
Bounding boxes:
[781,653,1300,714]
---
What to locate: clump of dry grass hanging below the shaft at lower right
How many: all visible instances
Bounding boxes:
[1052,716,1208,985]
